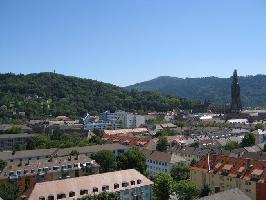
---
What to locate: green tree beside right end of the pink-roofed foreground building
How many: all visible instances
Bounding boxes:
[153,173,174,200]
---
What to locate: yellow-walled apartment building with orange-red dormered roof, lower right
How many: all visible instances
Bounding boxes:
[190,155,266,200]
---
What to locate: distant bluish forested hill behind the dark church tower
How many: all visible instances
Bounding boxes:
[126,75,266,107]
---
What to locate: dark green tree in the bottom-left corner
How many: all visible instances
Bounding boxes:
[0,183,22,200]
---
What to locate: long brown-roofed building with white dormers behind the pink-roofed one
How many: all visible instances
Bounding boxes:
[0,155,99,191]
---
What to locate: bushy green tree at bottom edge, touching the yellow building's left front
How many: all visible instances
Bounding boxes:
[174,180,200,200]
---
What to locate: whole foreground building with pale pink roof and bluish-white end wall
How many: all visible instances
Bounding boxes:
[29,169,153,200]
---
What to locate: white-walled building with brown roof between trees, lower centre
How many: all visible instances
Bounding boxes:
[143,150,187,176]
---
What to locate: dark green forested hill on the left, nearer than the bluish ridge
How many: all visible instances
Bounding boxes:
[0,73,198,123]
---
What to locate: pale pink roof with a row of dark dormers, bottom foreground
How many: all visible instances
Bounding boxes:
[29,169,153,200]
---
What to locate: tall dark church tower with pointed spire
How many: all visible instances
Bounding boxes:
[231,70,242,113]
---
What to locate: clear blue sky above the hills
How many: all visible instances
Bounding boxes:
[0,0,266,86]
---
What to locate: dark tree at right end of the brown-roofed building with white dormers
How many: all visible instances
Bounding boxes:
[91,150,117,173]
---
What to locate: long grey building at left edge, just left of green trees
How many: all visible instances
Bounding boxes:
[0,133,36,150]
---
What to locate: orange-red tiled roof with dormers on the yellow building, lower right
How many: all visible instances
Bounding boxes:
[191,155,266,183]
